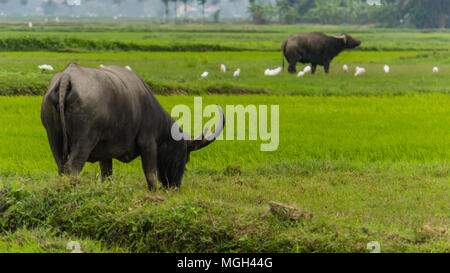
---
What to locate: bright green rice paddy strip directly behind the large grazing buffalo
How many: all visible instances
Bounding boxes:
[0,94,450,173]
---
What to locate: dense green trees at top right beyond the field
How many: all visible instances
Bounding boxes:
[249,0,450,28]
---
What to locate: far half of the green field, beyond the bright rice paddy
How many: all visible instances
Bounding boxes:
[0,22,450,95]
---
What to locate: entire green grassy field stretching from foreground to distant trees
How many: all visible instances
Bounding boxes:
[0,23,450,252]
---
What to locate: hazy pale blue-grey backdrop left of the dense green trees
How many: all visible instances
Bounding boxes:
[0,0,253,18]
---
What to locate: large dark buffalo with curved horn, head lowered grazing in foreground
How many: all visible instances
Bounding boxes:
[41,64,224,190]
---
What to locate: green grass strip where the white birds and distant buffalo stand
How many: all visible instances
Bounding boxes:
[0,51,450,96]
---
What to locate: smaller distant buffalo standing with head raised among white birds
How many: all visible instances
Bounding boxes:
[281,32,361,74]
